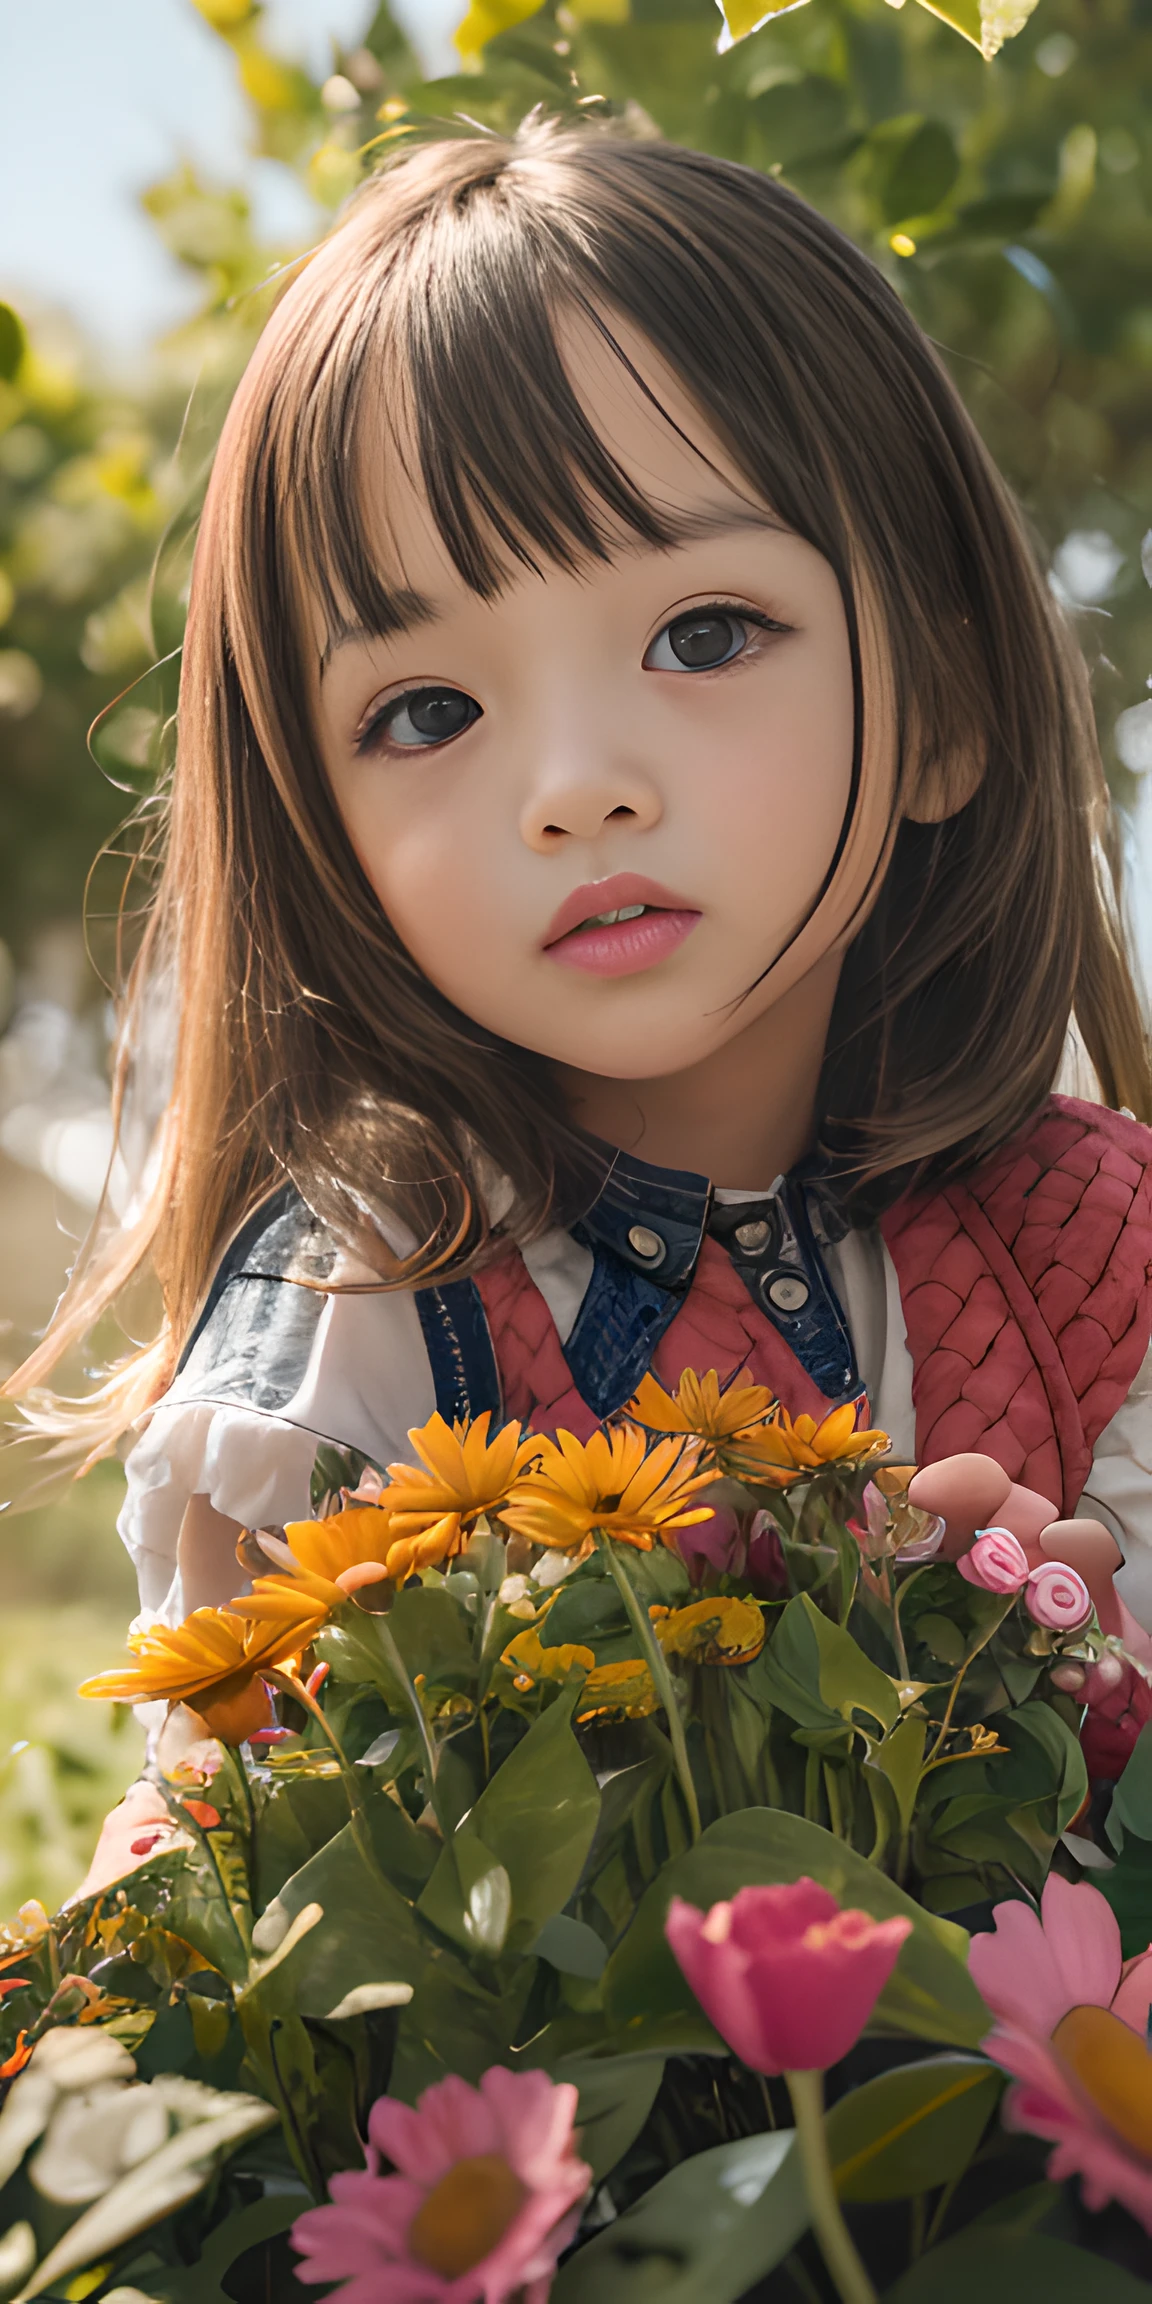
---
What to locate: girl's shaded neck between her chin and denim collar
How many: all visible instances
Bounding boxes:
[558,954,841,1191]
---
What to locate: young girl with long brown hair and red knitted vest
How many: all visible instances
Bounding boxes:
[21,124,1152,1861]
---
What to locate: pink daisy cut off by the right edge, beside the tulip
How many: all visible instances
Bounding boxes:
[968,1873,1152,2233]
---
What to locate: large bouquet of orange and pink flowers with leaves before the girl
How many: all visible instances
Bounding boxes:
[0,1373,1152,2304]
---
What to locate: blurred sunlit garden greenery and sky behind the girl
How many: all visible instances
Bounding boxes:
[0,0,1152,1912]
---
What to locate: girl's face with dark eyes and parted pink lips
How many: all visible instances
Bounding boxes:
[316,323,876,1081]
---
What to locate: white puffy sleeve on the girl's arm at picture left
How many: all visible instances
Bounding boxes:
[120,1225,435,1622]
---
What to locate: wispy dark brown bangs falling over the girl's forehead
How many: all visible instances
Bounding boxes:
[283,237,712,638]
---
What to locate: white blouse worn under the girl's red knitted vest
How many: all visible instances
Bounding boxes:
[120,1191,1152,1631]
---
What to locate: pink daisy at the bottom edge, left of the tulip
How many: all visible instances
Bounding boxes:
[293,2064,592,2304]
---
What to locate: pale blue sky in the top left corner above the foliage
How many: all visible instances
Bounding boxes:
[0,0,463,359]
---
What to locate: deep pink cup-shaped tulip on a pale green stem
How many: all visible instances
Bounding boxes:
[664,1880,912,2074]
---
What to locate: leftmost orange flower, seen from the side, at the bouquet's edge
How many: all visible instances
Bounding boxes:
[81,1587,327,1744]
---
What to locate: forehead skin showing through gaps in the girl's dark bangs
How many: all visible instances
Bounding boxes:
[336,313,772,626]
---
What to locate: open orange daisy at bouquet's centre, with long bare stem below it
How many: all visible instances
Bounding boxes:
[500,1424,712,1553]
